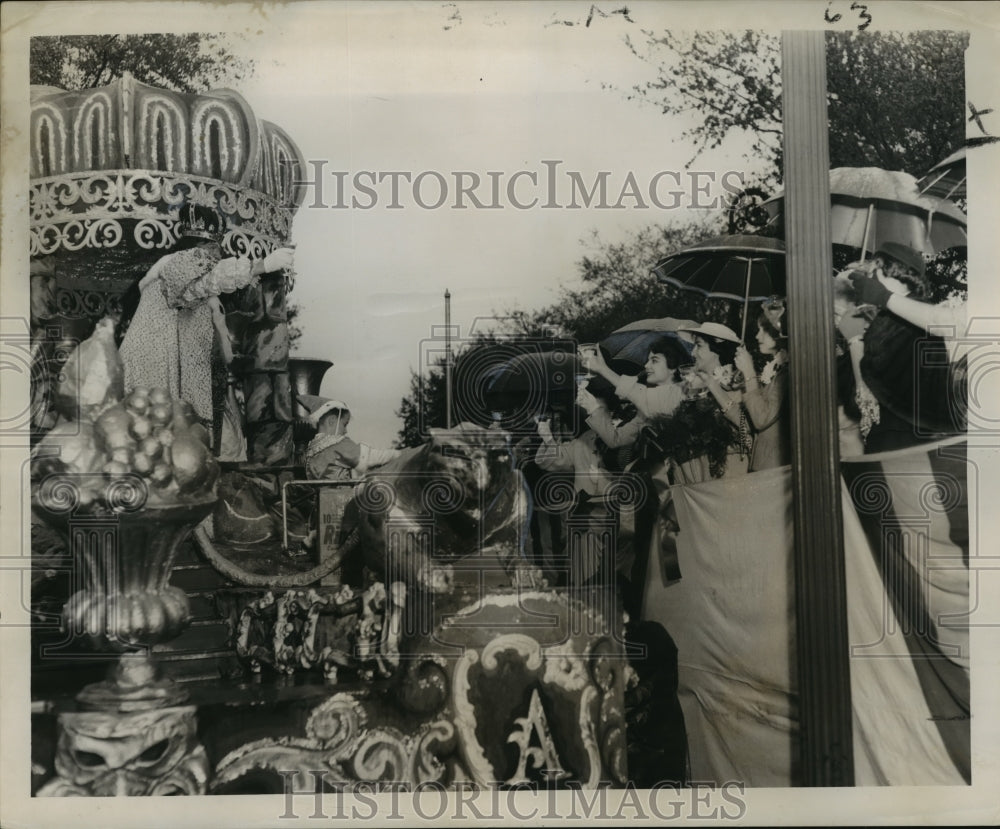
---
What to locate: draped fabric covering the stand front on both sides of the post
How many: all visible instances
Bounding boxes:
[644,440,970,787]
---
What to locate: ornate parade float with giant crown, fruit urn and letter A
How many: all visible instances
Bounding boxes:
[29,75,627,796]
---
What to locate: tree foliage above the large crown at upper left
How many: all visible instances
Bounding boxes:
[30,32,254,92]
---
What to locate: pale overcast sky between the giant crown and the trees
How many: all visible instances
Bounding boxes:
[232,3,761,443]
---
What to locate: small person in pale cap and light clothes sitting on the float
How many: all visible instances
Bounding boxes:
[299,394,399,481]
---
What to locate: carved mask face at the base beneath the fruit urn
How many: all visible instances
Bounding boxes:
[39,706,208,797]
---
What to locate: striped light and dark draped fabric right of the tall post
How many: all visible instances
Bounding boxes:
[841,439,971,785]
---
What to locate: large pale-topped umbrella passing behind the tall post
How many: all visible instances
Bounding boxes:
[763,167,969,259]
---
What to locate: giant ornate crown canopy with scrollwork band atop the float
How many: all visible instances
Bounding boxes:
[29,74,305,258]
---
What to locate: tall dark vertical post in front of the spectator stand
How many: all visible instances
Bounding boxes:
[781,31,854,786]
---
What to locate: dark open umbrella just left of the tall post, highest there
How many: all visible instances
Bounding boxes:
[652,234,785,338]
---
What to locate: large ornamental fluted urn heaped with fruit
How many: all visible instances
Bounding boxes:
[31,378,219,711]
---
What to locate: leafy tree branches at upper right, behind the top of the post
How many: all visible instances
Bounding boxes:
[627,30,969,186]
